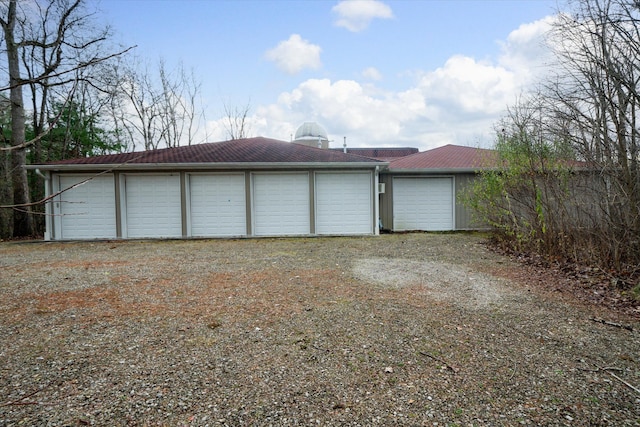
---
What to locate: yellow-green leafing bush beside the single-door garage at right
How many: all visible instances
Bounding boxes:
[465,124,572,255]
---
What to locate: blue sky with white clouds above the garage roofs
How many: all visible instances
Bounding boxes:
[99,0,558,150]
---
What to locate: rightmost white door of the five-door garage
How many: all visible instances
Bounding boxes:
[316,173,373,234]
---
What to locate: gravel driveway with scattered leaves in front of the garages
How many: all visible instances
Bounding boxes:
[0,233,640,426]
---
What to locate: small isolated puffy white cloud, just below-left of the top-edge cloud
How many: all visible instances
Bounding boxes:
[265,34,322,74]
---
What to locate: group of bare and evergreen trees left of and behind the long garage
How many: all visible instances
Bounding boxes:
[0,0,204,238]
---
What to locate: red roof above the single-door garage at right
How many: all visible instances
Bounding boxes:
[389,144,497,170]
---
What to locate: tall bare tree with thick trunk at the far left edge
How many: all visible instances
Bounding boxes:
[0,0,129,237]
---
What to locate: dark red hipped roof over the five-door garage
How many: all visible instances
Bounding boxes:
[47,137,378,165]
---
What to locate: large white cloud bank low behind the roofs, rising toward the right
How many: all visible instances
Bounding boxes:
[211,19,548,150]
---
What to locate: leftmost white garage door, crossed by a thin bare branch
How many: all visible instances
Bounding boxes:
[54,174,116,239]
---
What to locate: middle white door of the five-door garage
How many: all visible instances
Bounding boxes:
[189,174,247,237]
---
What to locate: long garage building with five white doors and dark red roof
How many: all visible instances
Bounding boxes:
[36,137,388,240]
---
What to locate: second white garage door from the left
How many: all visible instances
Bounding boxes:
[125,174,182,237]
